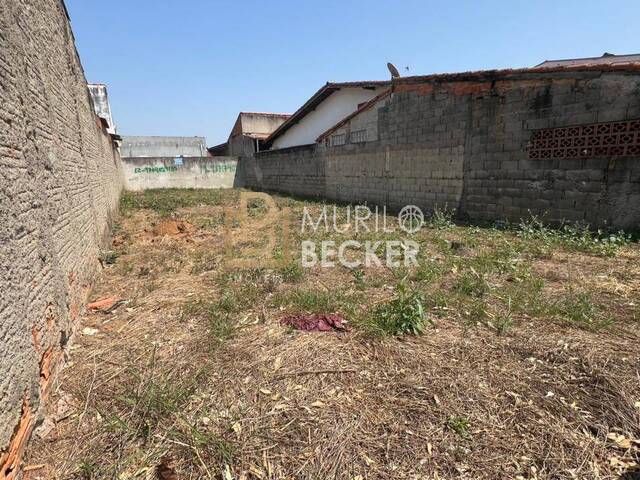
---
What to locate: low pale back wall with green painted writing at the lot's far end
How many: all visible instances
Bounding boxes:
[122,157,242,190]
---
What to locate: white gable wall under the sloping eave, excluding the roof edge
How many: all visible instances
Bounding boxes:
[272,87,388,149]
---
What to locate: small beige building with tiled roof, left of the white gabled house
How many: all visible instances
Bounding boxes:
[228,112,291,156]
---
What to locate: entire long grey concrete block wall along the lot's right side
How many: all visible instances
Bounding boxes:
[240,69,640,228]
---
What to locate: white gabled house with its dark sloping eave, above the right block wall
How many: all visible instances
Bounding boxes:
[264,81,391,149]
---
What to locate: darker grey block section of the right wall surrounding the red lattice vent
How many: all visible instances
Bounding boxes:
[461,72,640,228]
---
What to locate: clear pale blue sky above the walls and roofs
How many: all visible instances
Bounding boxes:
[65,0,640,146]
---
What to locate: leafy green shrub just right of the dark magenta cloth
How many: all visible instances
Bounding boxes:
[368,283,432,336]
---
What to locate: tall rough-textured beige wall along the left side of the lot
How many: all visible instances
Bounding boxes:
[0,0,123,479]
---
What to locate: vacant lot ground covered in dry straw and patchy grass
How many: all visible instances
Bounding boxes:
[22,190,640,480]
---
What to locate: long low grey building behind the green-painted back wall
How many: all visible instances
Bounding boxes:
[120,136,208,158]
